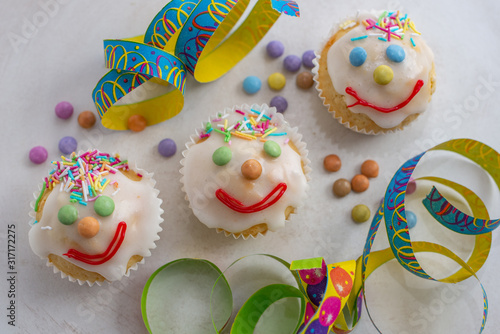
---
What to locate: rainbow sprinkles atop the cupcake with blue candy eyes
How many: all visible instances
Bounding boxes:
[350,11,421,47]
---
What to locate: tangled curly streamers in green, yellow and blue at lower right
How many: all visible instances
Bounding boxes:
[143,139,500,334]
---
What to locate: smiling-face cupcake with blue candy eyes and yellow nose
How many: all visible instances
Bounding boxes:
[314,11,436,134]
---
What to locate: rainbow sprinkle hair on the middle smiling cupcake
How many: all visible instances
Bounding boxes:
[199,108,287,143]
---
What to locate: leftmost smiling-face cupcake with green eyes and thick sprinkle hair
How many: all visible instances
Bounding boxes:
[29,150,163,285]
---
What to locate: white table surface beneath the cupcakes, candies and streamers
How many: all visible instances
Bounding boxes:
[0,0,500,333]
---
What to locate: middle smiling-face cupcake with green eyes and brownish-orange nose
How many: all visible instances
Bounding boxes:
[180,105,310,239]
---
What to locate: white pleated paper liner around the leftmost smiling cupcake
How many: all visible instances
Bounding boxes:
[29,151,164,286]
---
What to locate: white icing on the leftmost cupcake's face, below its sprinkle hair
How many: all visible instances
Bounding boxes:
[29,160,163,281]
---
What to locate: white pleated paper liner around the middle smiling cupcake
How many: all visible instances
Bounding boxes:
[179,104,311,240]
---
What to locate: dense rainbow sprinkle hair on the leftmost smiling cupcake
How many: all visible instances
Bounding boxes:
[35,150,129,211]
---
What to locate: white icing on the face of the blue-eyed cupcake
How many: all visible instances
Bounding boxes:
[327,13,434,128]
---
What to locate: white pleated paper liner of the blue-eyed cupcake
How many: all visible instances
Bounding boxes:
[311,10,426,135]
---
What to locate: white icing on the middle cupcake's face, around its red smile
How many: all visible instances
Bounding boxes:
[181,105,308,233]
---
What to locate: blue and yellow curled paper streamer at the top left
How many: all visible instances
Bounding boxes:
[92,0,300,130]
